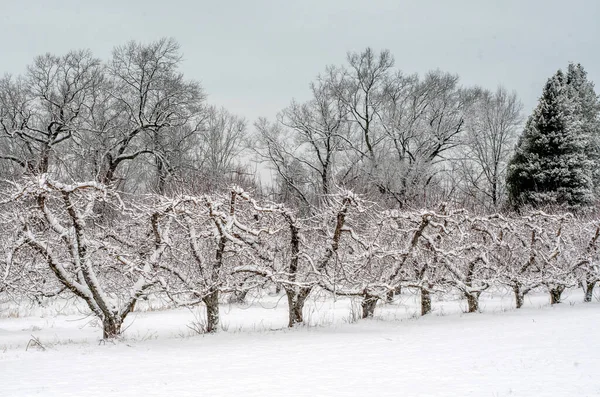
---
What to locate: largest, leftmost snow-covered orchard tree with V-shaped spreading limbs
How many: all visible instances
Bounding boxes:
[5,174,167,338]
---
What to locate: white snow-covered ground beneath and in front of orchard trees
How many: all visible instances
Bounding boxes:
[0,290,600,397]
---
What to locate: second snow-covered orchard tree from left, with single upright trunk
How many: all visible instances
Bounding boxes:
[150,188,261,333]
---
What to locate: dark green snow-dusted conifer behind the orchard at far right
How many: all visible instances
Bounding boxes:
[506,70,594,210]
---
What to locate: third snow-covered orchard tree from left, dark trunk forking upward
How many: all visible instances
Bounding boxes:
[234,192,356,327]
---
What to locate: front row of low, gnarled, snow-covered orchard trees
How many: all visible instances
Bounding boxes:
[0,174,600,338]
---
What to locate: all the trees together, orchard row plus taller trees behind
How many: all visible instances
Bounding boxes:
[0,39,600,338]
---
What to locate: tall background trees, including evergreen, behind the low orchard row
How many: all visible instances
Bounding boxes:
[0,39,600,212]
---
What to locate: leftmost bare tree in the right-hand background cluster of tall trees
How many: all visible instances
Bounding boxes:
[255,78,350,208]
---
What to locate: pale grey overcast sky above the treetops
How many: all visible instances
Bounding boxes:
[0,0,600,122]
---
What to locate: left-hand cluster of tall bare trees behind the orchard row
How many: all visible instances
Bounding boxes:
[0,39,246,193]
